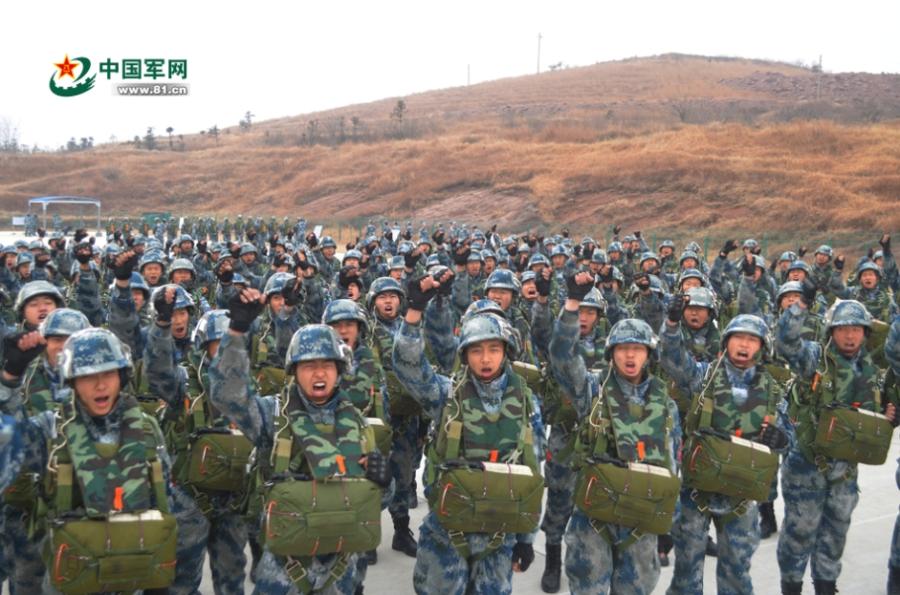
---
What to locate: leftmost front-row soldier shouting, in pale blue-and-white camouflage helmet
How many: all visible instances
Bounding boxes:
[0,328,184,593]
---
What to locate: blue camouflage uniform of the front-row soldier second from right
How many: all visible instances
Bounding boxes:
[660,323,790,595]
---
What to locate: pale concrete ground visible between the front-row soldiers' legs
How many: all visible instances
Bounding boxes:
[201,435,900,595]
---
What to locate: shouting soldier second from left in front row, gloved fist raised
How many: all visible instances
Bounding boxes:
[209,289,391,594]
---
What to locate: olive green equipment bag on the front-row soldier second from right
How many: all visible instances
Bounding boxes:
[681,395,778,502]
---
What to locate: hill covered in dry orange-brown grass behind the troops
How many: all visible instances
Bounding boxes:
[0,55,900,246]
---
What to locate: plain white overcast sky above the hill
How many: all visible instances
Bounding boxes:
[0,0,900,148]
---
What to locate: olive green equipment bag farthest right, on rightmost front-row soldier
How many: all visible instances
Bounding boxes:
[813,404,894,465]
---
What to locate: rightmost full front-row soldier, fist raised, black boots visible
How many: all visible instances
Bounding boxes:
[776,300,896,595]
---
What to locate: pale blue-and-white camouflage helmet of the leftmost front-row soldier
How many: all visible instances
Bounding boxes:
[59,327,131,382]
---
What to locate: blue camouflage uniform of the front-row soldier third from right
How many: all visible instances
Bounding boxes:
[542,310,681,594]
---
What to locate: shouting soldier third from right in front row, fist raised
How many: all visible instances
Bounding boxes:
[542,274,680,594]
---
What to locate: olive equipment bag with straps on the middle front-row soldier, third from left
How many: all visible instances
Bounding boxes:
[426,378,544,538]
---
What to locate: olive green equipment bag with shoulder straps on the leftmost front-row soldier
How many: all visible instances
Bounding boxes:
[43,436,178,595]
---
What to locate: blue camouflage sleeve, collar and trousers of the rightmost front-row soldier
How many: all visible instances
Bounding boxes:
[775,304,869,582]
